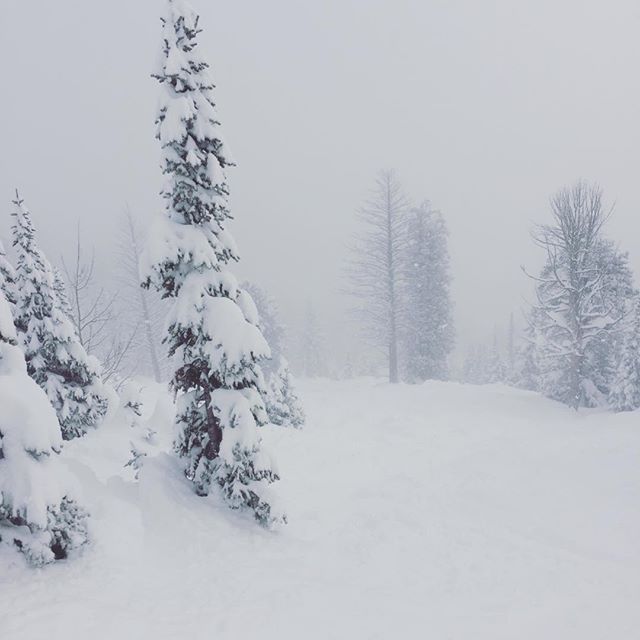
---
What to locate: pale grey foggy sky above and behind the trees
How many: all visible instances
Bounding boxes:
[0,0,640,364]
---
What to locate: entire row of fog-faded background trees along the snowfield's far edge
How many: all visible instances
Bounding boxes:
[40,171,640,415]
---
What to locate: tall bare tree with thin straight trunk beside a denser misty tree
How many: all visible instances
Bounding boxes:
[348,170,408,382]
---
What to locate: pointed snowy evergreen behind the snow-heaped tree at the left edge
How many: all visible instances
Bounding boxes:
[12,196,107,440]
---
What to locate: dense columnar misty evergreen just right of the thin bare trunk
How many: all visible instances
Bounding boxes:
[402,202,454,382]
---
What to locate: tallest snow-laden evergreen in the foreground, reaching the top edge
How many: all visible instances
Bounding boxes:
[142,0,284,526]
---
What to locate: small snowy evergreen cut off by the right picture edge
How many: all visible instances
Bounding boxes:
[609,299,640,411]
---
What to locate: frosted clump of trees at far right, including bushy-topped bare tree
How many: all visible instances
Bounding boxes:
[463,181,640,411]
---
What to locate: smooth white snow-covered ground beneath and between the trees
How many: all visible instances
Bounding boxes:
[0,380,640,640]
